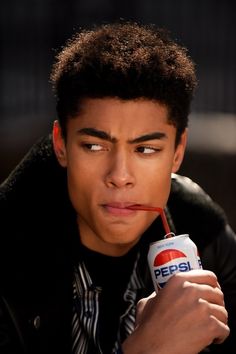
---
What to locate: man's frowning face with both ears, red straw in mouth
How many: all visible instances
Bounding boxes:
[53,98,186,256]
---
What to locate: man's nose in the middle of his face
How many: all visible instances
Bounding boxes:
[105,152,135,188]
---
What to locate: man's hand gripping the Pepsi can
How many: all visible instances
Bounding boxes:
[123,270,230,354]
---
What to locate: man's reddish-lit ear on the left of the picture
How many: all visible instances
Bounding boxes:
[52,120,67,167]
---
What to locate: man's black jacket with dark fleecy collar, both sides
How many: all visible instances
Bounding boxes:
[0,137,236,354]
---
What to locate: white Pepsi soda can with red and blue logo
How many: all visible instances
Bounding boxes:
[148,234,202,292]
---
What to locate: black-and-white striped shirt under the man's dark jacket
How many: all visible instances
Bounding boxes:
[72,254,144,354]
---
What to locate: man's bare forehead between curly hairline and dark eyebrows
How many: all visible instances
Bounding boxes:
[67,98,175,139]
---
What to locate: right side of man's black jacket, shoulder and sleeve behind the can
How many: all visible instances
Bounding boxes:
[168,175,236,354]
